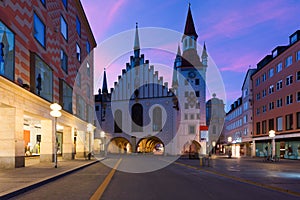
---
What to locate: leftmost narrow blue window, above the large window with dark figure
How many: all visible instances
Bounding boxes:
[33,13,46,47]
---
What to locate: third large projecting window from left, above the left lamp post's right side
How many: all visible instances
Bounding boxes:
[59,79,73,113]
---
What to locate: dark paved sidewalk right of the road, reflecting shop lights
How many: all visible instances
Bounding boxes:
[178,156,300,196]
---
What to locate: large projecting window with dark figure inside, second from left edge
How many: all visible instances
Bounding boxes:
[30,54,53,102]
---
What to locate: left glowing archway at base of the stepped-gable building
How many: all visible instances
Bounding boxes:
[107,137,132,153]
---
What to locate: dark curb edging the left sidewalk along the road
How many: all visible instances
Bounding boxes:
[0,160,100,200]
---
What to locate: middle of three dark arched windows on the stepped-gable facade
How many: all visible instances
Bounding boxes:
[131,103,143,132]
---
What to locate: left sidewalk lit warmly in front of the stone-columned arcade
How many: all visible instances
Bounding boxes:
[0,159,99,199]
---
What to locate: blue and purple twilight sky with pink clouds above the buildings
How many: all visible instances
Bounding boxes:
[81,0,300,110]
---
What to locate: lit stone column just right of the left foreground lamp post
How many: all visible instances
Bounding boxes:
[62,126,73,160]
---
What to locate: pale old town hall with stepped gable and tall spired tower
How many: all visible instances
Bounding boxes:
[95,7,208,155]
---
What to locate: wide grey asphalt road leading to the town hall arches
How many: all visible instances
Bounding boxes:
[8,156,299,200]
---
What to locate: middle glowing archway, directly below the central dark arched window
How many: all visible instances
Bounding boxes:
[137,136,165,155]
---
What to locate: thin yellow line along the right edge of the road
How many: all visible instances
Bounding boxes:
[174,162,300,196]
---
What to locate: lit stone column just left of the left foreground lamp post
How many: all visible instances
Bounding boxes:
[40,119,55,162]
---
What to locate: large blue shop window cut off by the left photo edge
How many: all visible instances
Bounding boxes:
[0,21,15,81]
